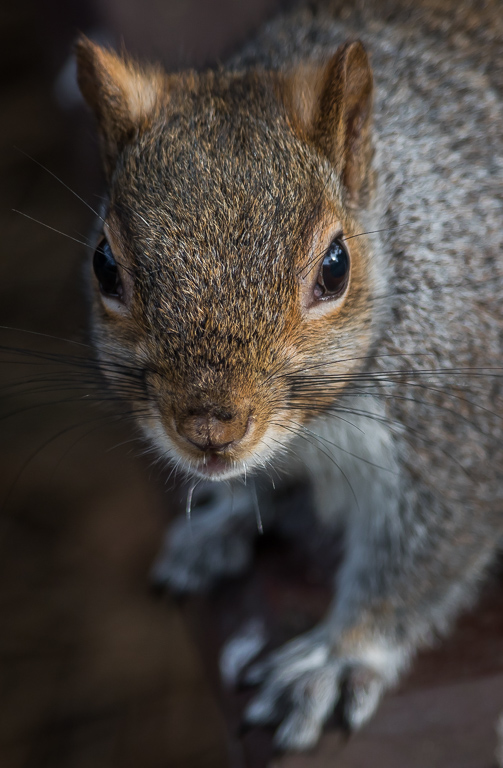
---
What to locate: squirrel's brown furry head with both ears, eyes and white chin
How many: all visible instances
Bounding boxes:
[77,39,379,479]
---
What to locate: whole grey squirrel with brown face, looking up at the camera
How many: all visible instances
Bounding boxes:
[76,0,503,750]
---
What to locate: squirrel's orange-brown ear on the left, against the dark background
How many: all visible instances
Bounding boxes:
[75,36,166,173]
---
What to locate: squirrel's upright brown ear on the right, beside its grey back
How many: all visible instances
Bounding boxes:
[288,41,373,204]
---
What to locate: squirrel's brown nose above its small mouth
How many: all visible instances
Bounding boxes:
[177,410,250,453]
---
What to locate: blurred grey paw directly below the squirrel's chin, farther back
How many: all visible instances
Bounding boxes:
[151,483,254,593]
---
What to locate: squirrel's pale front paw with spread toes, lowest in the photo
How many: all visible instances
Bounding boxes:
[244,628,389,751]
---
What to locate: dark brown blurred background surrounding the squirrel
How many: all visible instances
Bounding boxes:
[0,0,503,768]
